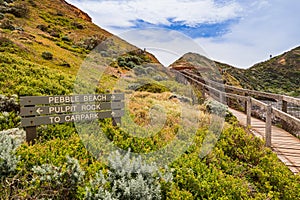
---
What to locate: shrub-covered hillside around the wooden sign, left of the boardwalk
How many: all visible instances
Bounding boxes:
[0,0,300,200]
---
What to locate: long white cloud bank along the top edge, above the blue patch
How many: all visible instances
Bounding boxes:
[69,0,242,28]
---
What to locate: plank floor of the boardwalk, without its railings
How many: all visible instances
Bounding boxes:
[229,108,300,174]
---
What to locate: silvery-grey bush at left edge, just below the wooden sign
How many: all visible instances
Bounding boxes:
[0,132,19,176]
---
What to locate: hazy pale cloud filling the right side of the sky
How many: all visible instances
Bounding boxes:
[196,0,300,68]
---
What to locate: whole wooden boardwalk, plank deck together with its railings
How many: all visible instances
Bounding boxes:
[178,70,300,174]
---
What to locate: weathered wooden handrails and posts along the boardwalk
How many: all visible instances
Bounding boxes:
[178,71,300,147]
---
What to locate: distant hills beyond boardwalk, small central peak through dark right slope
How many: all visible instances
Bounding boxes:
[170,47,300,96]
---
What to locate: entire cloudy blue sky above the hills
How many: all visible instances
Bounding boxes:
[67,0,300,68]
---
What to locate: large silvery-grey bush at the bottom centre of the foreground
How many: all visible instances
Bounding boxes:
[85,152,172,200]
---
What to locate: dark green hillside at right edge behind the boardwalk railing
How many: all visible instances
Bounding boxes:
[220,47,300,96]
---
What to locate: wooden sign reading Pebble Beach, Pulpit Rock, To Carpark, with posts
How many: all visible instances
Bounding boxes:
[20,94,125,142]
